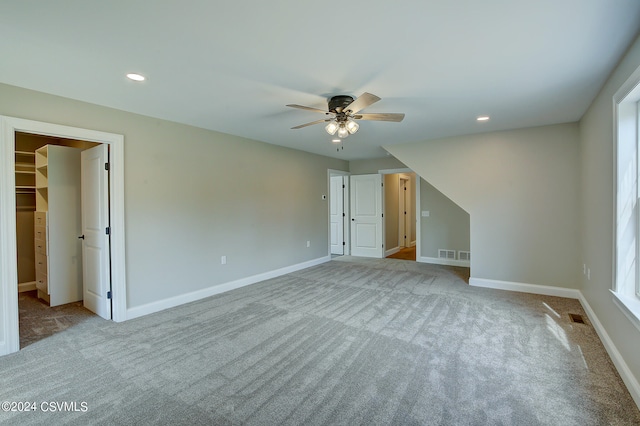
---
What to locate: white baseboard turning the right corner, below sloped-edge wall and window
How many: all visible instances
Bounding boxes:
[469,278,640,409]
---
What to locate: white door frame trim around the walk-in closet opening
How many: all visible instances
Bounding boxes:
[0,116,126,355]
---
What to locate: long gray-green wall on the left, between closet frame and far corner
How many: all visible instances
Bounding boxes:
[0,84,348,308]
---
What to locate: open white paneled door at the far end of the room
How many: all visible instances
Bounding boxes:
[351,174,384,258]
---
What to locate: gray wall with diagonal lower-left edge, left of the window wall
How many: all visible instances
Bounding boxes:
[386,123,582,288]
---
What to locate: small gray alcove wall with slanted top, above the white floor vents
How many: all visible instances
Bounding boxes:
[419,179,470,258]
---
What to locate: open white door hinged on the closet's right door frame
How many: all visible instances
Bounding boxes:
[82,144,111,319]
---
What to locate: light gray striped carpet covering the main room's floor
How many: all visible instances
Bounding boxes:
[0,256,640,425]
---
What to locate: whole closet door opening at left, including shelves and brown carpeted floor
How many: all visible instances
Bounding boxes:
[15,132,101,348]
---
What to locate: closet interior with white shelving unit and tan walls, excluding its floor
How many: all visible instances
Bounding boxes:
[15,133,98,306]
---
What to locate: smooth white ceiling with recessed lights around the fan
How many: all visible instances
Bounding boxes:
[0,0,640,160]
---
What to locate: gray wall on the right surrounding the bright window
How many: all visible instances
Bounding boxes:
[580,33,640,396]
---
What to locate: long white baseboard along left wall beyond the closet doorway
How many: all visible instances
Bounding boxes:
[127,256,331,320]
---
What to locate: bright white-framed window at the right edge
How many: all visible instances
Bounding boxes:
[612,68,640,329]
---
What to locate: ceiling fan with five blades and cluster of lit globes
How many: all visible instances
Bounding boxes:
[287,92,404,139]
